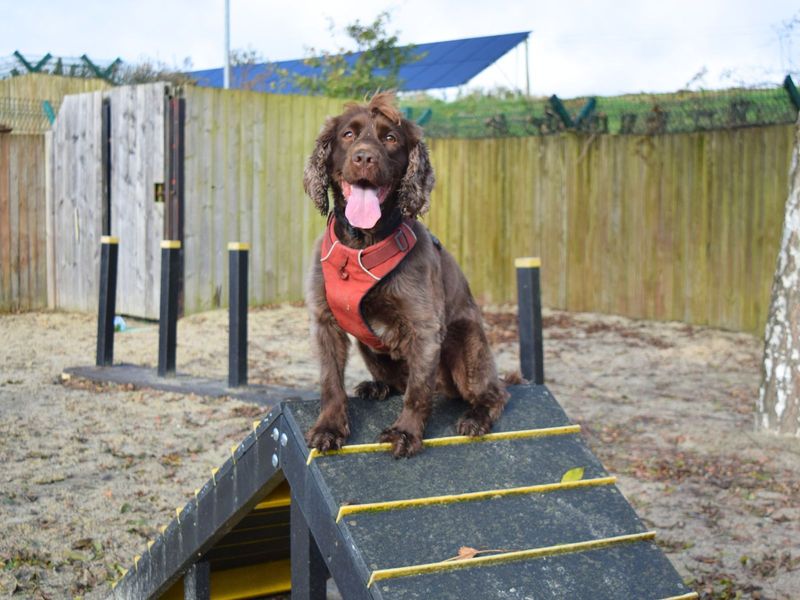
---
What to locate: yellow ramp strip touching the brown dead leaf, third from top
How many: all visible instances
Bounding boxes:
[367,531,656,587]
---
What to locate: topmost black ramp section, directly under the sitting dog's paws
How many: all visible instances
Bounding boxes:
[291,385,570,444]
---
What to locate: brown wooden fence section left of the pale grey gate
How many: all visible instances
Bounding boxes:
[0,133,47,312]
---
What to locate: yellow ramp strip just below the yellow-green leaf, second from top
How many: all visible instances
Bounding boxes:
[336,477,617,523]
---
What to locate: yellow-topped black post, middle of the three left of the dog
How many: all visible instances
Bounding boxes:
[158,240,181,377]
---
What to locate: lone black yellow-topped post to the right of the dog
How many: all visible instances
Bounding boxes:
[514,258,544,385]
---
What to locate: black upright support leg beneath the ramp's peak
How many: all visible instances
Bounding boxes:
[289,498,328,600]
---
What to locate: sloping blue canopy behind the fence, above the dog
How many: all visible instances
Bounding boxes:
[188,31,530,94]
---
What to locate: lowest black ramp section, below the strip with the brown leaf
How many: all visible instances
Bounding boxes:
[371,542,691,600]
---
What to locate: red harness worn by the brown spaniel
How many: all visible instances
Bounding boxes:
[320,218,417,350]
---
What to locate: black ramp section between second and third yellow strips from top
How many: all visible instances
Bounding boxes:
[342,485,646,571]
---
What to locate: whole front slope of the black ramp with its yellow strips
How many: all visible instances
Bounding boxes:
[283,386,690,600]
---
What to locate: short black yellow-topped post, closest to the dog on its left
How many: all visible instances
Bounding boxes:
[228,242,250,387]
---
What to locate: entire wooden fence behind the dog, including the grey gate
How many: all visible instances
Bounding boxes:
[0,84,794,334]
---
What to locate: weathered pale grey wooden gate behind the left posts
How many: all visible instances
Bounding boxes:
[50,83,169,319]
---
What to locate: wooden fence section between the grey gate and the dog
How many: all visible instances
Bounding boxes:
[184,87,342,312]
